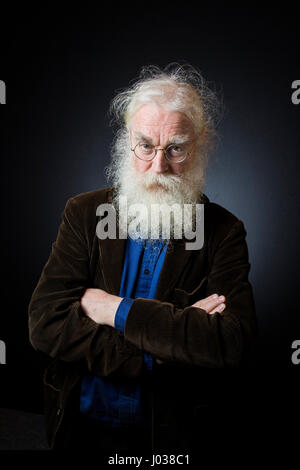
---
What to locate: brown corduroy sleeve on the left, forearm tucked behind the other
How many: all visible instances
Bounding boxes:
[28,198,143,376]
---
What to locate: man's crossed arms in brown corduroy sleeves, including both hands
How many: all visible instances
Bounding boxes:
[29,199,256,376]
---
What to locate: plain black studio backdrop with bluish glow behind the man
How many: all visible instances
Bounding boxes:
[0,2,300,448]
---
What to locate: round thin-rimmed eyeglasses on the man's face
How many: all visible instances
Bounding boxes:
[131,142,190,163]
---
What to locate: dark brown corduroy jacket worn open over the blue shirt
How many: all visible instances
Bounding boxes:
[29,188,257,448]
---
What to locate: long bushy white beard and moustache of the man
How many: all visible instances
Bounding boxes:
[107,129,205,238]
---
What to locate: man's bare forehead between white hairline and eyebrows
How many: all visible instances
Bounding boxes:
[131,104,193,135]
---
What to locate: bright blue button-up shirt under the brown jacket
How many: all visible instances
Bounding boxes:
[80,238,167,426]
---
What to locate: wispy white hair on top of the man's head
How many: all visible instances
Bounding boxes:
[110,63,221,151]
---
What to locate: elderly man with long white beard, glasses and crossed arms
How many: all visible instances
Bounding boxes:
[29,65,256,455]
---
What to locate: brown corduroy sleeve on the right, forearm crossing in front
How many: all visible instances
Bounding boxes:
[124,220,257,367]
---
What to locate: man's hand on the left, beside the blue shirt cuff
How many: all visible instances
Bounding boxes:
[80,289,122,327]
